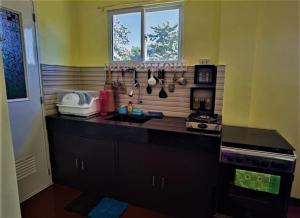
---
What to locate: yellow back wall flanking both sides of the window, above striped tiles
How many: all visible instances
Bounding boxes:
[77,1,220,66]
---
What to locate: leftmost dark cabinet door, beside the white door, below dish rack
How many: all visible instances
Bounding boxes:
[49,133,81,189]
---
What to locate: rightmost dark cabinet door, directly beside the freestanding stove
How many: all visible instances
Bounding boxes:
[151,146,218,218]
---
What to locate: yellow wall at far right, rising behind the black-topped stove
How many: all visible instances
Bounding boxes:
[250,2,300,197]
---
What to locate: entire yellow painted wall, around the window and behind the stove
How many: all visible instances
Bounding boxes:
[37,0,300,198]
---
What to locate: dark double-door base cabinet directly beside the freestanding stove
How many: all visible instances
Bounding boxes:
[119,142,218,217]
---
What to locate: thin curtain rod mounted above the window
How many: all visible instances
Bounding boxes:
[97,0,184,12]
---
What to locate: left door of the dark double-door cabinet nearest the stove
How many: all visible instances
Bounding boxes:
[118,142,158,209]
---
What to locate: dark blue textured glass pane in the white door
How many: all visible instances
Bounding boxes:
[0,8,27,100]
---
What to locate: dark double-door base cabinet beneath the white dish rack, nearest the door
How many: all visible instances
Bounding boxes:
[49,129,116,196]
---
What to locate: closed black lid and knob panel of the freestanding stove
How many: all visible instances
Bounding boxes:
[220,126,297,173]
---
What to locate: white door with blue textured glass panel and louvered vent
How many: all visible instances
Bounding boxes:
[0,0,51,202]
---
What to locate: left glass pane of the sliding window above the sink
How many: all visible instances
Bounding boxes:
[112,12,141,61]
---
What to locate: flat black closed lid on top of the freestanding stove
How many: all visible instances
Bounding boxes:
[222,126,294,154]
